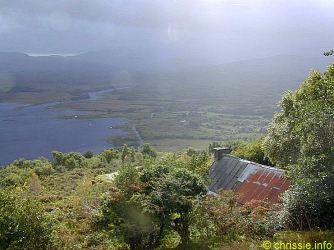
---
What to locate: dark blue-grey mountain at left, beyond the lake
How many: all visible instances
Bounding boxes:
[0,49,145,90]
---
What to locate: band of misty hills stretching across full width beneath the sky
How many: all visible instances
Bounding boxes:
[0,49,331,97]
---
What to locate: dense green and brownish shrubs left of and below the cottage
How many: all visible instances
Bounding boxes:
[0,144,280,249]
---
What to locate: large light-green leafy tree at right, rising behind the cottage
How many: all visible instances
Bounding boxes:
[264,65,334,167]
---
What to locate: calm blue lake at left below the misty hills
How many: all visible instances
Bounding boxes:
[0,89,126,166]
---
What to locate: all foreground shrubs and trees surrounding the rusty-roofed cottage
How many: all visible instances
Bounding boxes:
[0,65,334,249]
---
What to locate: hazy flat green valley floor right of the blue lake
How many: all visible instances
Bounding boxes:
[53,85,276,151]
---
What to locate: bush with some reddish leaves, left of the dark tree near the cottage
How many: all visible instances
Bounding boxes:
[96,164,162,249]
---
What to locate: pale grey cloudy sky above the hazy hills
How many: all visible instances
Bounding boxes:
[0,0,334,61]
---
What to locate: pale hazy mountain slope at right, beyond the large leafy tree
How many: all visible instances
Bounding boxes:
[141,55,334,96]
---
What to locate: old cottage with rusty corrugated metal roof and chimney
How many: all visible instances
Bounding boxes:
[209,148,290,204]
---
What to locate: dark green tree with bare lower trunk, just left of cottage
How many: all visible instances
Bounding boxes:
[140,166,206,245]
